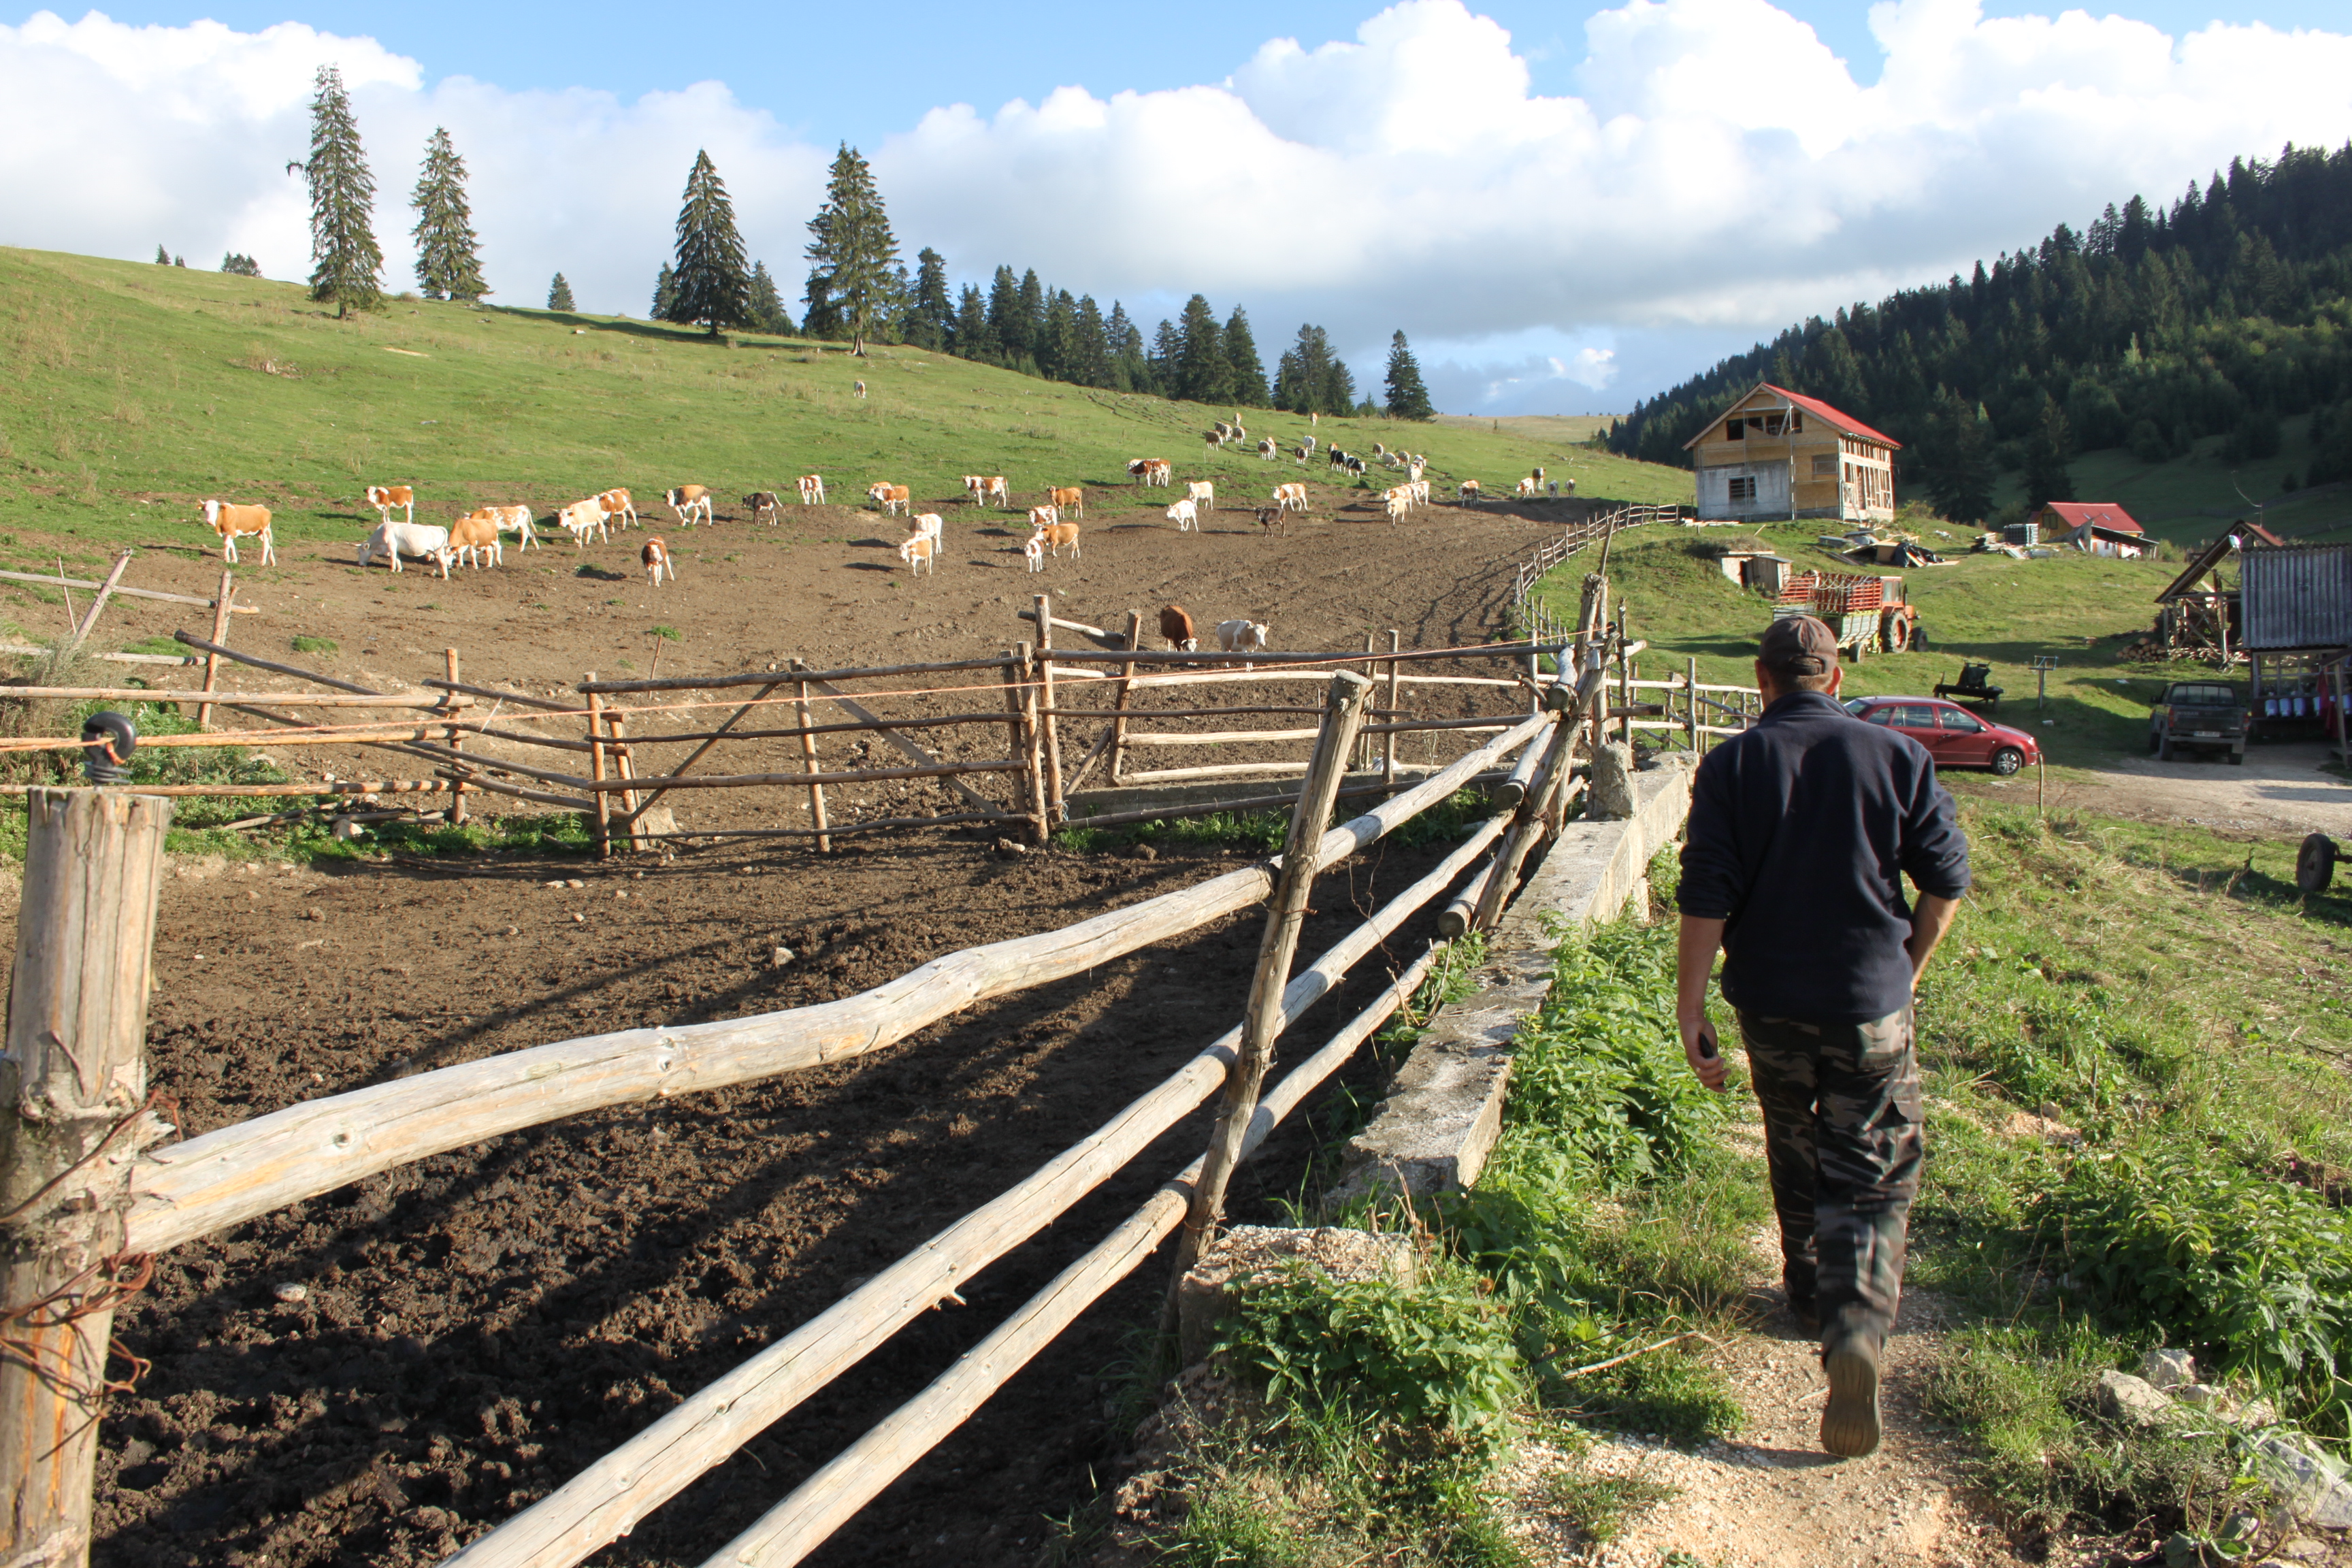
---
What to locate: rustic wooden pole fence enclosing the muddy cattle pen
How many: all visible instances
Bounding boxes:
[0,616,1646,1568]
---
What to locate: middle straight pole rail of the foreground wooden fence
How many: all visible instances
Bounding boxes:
[449,818,1505,1568]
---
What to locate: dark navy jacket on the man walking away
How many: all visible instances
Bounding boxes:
[1677,691,1969,1023]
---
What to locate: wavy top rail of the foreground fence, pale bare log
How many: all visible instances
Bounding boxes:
[122,715,1550,1253]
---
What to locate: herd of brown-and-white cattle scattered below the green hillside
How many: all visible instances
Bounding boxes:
[202,456,1576,597]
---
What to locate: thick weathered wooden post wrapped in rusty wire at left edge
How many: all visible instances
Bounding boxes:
[0,790,172,1568]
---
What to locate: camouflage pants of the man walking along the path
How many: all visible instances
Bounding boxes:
[1740,1009,1924,1335]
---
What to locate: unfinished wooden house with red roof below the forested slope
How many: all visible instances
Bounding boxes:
[1684,381,1903,522]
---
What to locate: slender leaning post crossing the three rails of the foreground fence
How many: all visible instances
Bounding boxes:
[1162,670,1371,1330]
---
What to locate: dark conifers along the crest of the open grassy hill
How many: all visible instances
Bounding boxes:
[277,66,1433,419]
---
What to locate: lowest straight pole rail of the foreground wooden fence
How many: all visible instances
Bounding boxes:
[703,945,1437,1568]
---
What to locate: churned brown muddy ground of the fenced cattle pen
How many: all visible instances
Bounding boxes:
[5,493,1590,1568]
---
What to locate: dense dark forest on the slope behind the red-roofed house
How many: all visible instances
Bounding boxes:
[1606,144,2352,522]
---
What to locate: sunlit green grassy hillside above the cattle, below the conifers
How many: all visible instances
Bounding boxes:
[0,249,1691,555]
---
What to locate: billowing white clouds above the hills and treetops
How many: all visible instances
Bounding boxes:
[0,0,2352,407]
